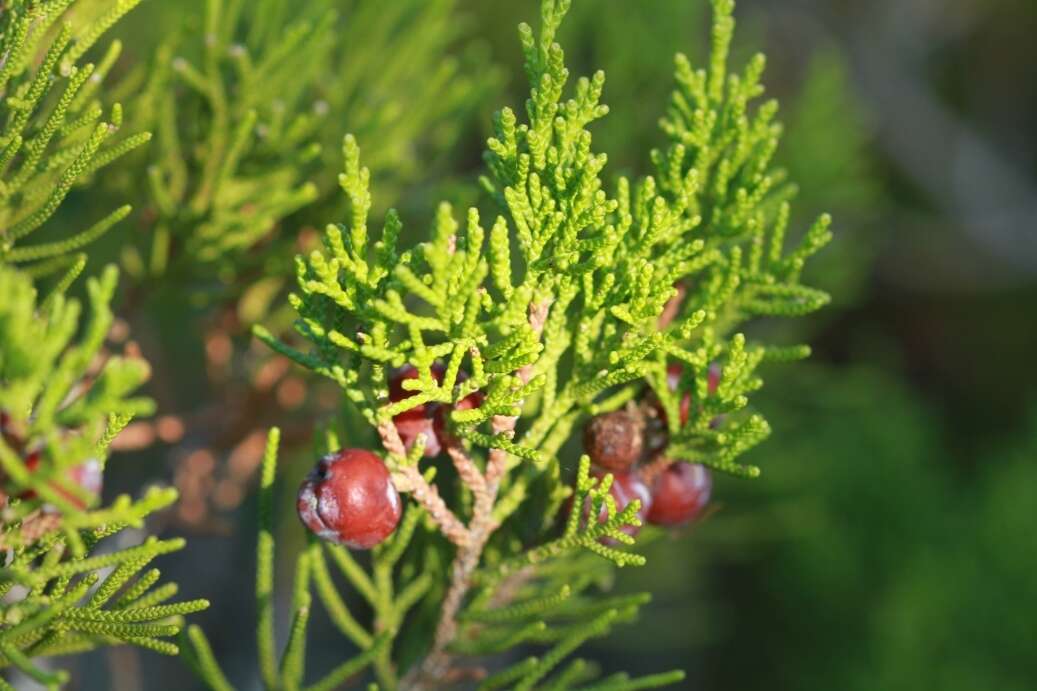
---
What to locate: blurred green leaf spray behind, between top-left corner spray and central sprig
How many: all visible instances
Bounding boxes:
[112,0,495,298]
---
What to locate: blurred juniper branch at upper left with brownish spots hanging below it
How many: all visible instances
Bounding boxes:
[95,0,497,528]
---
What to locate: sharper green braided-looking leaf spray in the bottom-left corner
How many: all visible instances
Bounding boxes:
[0,524,208,689]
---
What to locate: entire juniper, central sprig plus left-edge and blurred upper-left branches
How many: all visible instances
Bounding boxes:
[0,0,831,691]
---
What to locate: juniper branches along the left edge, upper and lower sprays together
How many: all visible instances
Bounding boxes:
[0,5,207,689]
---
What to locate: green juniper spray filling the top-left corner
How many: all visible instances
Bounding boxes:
[0,0,150,280]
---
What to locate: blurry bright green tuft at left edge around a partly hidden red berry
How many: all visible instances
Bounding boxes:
[0,265,153,522]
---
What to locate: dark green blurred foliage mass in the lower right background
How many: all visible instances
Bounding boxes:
[717,368,1037,691]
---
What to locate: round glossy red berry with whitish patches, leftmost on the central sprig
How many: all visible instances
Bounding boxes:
[296,448,402,550]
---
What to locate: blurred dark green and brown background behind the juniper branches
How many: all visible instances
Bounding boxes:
[36,0,1037,691]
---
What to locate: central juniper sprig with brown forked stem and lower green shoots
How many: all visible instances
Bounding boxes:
[192,0,831,689]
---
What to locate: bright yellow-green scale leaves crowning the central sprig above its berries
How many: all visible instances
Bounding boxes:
[269,2,831,506]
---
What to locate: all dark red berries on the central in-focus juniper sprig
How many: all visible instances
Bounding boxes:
[297,363,720,549]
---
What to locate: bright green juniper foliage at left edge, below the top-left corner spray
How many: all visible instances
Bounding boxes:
[0,266,207,688]
